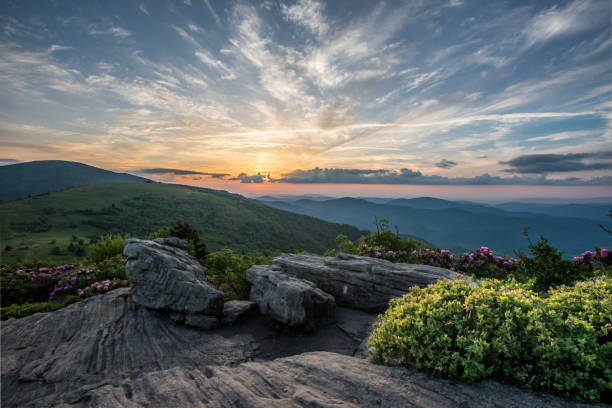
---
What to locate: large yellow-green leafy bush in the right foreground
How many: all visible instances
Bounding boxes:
[368,277,612,401]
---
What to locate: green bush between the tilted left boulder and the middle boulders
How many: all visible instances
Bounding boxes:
[205,249,271,299]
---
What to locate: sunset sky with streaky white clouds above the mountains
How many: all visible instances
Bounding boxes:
[0,0,612,196]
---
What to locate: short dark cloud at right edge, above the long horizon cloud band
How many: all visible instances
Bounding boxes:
[499,150,612,174]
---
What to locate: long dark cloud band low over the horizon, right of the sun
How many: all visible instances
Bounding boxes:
[270,167,612,186]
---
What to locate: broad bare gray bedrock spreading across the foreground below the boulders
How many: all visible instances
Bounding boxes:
[0,288,588,408]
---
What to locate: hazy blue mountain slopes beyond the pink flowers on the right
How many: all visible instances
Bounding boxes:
[266,198,612,256]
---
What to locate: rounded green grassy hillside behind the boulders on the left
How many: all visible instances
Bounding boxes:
[0,183,362,264]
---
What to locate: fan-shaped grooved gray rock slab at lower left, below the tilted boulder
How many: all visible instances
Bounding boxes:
[0,288,255,408]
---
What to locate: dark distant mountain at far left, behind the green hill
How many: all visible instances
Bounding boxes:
[0,160,149,201]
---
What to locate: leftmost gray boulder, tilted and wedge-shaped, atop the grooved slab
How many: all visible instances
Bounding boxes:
[123,238,223,316]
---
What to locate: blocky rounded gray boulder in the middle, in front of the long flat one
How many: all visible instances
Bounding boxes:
[247,265,336,331]
